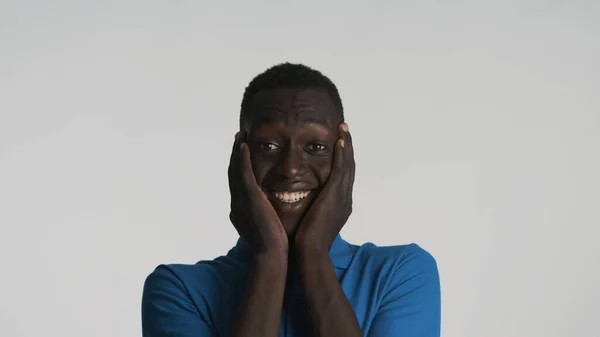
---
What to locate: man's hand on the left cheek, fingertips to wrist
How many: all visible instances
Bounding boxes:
[228,132,288,254]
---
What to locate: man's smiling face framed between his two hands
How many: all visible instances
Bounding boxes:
[245,88,343,236]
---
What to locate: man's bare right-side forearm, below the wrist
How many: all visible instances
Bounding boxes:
[298,252,362,337]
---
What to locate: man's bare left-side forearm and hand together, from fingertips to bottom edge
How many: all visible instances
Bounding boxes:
[229,133,288,337]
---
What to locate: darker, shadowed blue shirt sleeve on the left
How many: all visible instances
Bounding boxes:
[142,266,215,337]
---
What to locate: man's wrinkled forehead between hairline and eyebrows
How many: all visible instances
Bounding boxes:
[250,88,342,128]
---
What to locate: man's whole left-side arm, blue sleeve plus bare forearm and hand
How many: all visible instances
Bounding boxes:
[142,133,288,337]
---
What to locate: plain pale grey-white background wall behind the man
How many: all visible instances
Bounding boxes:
[0,0,600,337]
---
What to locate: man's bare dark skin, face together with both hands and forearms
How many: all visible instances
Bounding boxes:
[229,88,362,337]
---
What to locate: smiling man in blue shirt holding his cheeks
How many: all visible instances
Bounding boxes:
[142,63,440,337]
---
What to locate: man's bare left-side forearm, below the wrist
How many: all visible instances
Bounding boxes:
[231,253,288,337]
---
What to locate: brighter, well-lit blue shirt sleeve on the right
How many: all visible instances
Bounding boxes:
[367,244,441,337]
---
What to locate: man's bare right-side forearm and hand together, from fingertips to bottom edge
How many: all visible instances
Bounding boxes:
[294,123,363,337]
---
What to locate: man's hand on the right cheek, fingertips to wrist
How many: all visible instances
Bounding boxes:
[294,123,355,254]
